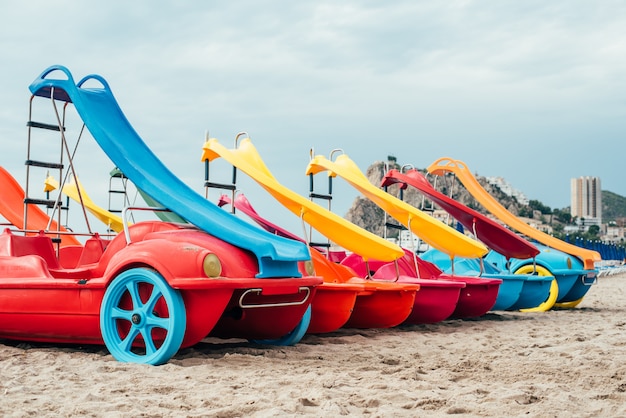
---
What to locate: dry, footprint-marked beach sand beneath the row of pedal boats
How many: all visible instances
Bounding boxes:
[0,274,626,417]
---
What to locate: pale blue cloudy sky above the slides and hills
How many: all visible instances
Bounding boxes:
[0,0,626,233]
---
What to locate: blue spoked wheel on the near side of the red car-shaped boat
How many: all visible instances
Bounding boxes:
[100,268,187,365]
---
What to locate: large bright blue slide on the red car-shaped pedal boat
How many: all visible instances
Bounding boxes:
[29,65,310,278]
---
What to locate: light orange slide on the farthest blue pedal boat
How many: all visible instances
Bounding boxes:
[428,157,602,270]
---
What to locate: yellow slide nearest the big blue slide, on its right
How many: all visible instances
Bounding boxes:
[202,138,404,261]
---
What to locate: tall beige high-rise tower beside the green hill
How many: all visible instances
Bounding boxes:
[570,177,602,225]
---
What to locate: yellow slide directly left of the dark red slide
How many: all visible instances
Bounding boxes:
[306,154,489,258]
